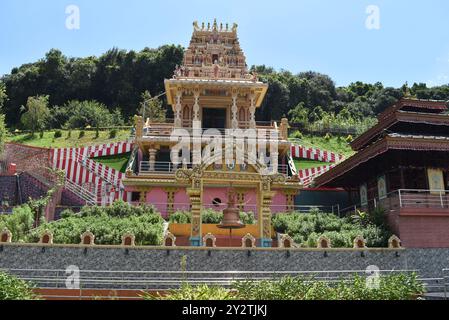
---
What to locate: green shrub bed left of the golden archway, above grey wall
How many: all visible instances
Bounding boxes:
[28,201,164,245]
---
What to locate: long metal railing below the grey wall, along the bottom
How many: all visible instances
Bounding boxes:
[1,269,417,290]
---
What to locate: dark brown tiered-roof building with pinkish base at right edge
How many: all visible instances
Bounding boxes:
[315,98,449,247]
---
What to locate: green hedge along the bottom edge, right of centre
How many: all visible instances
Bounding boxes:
[144,274,424,300]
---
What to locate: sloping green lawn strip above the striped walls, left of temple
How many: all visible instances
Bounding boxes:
[6,130,130,148]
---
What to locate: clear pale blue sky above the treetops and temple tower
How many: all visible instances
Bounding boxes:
[0,0,449,86]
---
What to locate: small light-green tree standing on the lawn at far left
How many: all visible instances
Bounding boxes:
[21,96,50,136]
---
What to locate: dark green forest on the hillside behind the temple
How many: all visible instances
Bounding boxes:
[0,45,449,132]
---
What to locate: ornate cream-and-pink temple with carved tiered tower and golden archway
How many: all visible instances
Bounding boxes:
[122,21,301,247]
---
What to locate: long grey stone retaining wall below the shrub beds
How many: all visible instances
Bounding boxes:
[0,244,449,277]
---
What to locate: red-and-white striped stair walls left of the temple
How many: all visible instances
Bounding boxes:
[51,142,133,203]
